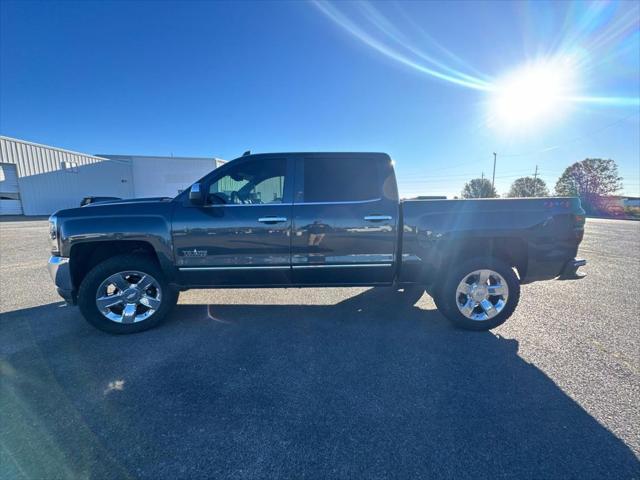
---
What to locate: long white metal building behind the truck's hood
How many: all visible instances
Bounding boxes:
[0,136,224,215]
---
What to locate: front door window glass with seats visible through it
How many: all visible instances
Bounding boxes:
[208,158,287,205]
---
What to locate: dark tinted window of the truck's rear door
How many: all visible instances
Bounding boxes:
[304,158,380,202]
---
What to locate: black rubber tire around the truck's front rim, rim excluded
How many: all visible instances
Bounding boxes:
[78,254,178,334]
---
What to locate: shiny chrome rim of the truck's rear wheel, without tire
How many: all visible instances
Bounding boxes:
[456,270,509,321]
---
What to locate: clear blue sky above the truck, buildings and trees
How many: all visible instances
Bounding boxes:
[0,1,640,196]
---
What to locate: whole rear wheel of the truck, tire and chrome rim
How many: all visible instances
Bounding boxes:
[437,257,520,330]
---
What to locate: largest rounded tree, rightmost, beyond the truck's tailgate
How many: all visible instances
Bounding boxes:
[556,158,622,212]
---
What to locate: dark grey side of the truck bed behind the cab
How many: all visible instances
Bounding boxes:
[399,197,584,283]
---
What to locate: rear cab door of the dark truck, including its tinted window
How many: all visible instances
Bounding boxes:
[291,154,399,285]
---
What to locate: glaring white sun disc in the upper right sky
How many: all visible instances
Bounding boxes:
[490,60,575,130]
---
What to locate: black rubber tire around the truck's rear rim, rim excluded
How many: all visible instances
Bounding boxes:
[435,257,520,331]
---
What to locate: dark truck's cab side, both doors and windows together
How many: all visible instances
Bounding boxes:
[172,153,399,287]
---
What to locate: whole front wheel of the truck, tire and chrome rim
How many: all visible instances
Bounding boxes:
[78,255,178,334]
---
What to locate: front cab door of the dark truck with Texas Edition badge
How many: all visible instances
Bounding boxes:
[173,155,293,286]
